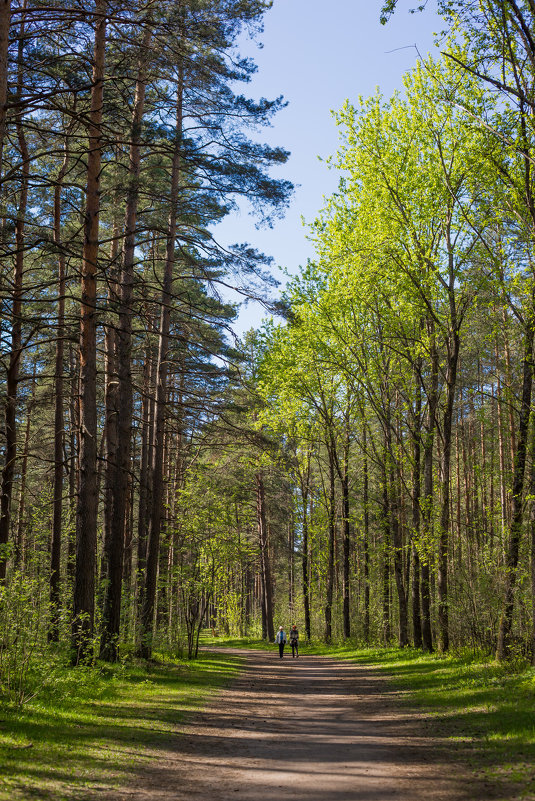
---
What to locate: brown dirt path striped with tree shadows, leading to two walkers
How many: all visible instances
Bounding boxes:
[111,651,500,801]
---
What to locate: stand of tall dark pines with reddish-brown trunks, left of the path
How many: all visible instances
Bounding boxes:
[0,0,291,664]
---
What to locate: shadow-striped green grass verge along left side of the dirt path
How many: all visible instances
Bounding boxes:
[0,652,241,801]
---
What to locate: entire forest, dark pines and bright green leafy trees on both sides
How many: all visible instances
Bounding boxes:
[0,0,535,698]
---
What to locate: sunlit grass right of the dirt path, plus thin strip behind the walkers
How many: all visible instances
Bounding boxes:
[212,638,535,801]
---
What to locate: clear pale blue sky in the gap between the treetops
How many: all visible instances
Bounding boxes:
[214,0,442,334]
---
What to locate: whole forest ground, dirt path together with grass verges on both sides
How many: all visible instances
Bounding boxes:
[0,640,535,801]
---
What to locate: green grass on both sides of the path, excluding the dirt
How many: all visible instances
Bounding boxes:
[0,637,535,801]
